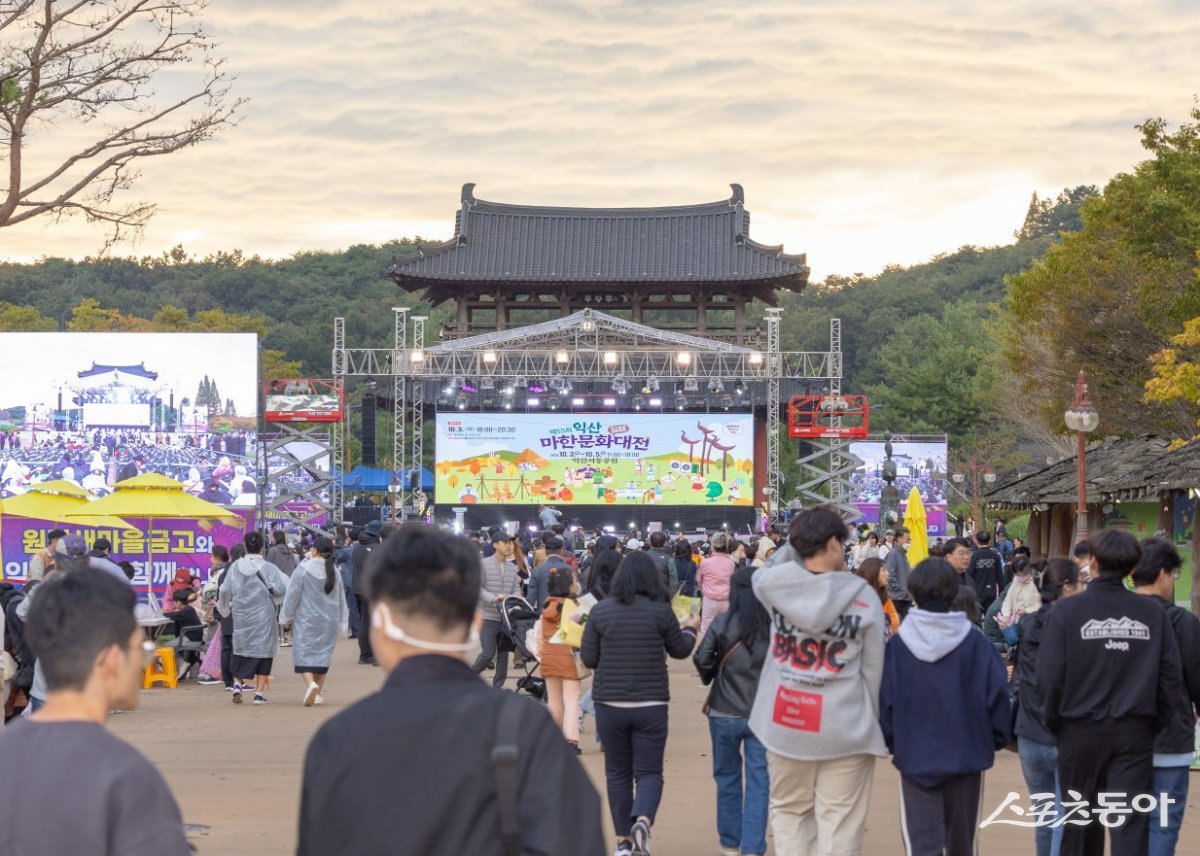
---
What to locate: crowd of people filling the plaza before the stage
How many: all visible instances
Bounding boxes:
[0,507,1200,856]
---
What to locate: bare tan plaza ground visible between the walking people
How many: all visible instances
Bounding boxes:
[109,640,1200,856]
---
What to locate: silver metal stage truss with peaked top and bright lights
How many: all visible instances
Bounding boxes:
[331,307,857,521]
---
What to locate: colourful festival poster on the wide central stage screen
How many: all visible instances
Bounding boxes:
[434,413,754,505]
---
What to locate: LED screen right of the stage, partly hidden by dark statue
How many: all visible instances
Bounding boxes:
[850,436,947,535]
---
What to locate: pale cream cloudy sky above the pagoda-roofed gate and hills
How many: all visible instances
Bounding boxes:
[0,0,1200,277]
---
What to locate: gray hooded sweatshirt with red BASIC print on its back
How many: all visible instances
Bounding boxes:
[750,561,887,761]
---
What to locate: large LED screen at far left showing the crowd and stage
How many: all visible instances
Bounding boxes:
[0,333,258,505]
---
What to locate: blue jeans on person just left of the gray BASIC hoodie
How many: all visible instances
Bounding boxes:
[708,716,770,854]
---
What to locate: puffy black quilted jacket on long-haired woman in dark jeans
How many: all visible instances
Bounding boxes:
[580,595,696,701]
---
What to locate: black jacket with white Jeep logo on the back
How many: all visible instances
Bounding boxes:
[1037,577,1183,734]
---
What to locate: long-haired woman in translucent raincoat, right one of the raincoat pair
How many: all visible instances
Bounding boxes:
[280,535,349,707]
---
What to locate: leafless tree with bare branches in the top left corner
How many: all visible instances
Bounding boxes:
[0,0,244,245]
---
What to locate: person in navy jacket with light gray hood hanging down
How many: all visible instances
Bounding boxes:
[880,558,1013,856]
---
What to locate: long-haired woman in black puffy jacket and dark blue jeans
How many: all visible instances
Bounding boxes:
[580,552,700,856]
